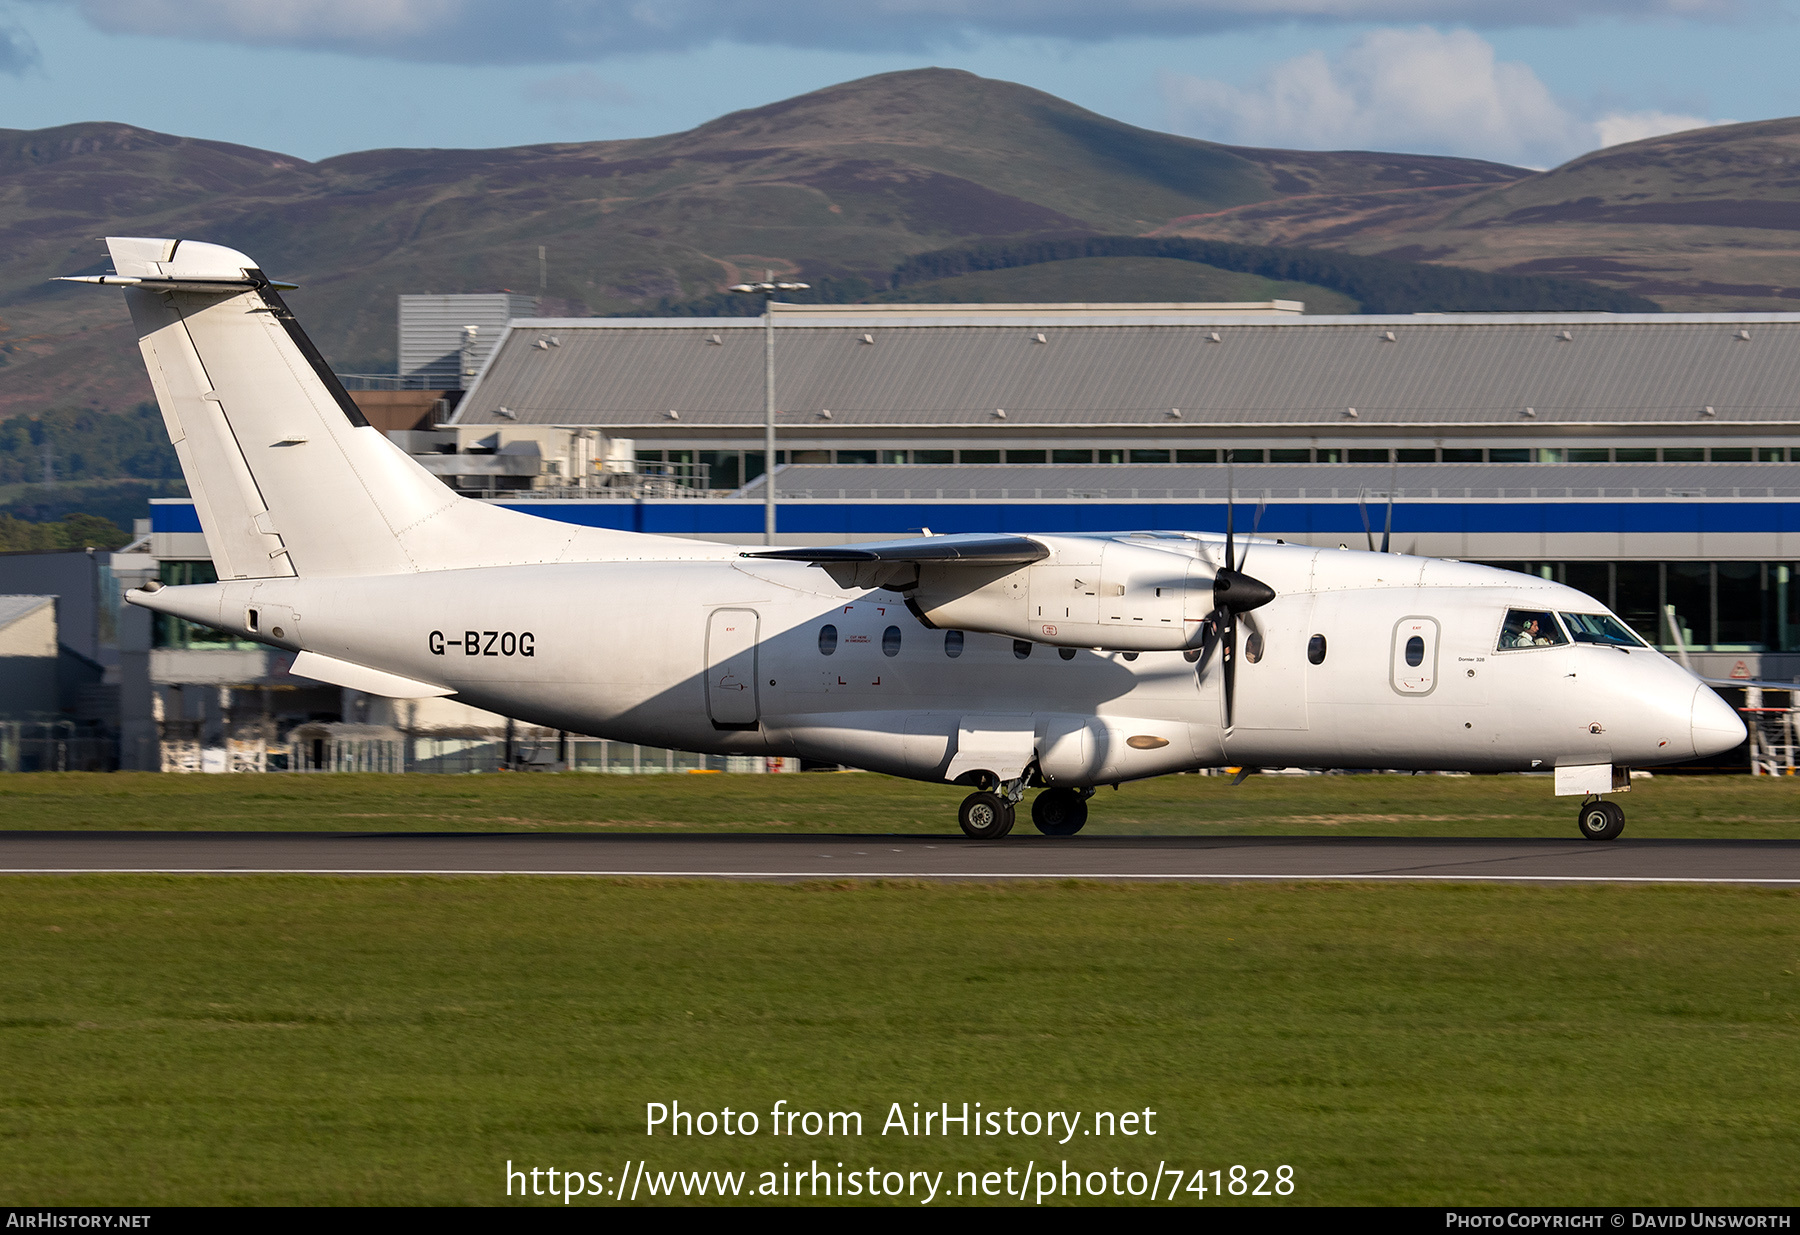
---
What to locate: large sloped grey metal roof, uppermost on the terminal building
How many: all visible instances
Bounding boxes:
[457,311,1800,434]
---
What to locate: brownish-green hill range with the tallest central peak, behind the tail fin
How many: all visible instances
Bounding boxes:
[0,68,1526,414]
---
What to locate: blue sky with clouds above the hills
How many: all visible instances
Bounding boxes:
[0,0,1800,167]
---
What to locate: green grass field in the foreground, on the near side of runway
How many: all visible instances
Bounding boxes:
[0,882,1800,1204]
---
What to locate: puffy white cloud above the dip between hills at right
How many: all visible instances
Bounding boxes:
[1163,27,1715,167]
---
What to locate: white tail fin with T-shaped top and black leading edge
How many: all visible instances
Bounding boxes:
[74,238,684,580]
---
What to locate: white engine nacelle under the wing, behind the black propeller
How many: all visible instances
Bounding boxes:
[905,536,1213,652]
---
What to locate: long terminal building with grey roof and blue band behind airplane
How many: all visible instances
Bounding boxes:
[31,302,1800,771]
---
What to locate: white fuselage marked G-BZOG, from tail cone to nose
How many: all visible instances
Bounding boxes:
[153,538,1742,785]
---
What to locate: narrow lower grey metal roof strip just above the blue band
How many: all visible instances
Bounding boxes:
[736,463,1800,502]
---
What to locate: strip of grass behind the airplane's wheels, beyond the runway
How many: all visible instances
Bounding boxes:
[0,772,1800,839]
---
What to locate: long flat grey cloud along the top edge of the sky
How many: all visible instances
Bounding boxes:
[34,0,1777,65]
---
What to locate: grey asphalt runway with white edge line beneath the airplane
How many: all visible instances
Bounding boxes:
[0,832,1800,888]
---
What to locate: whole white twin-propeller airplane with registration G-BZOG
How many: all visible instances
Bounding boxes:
[72,238,1749,841]
